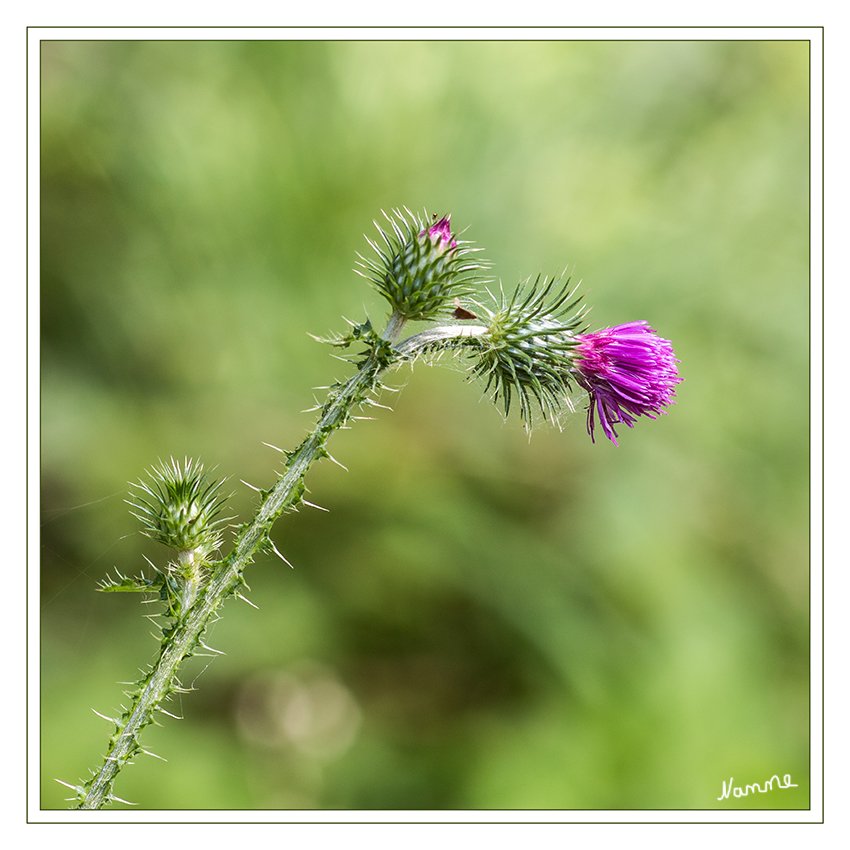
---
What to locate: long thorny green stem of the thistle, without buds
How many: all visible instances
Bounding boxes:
[75,313,440,809]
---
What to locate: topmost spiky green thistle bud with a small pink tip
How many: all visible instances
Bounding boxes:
[358,209,488,321]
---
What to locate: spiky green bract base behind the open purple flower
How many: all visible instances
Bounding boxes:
[469,276,585,425]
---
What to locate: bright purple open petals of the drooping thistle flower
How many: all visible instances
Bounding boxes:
[576,322,682,446]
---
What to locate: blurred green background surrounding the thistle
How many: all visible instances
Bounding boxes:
[41,41,809,809]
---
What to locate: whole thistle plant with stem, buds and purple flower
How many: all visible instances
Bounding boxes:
[63,209,681,809]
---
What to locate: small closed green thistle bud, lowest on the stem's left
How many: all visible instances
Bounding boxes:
[130,458,227,562]
